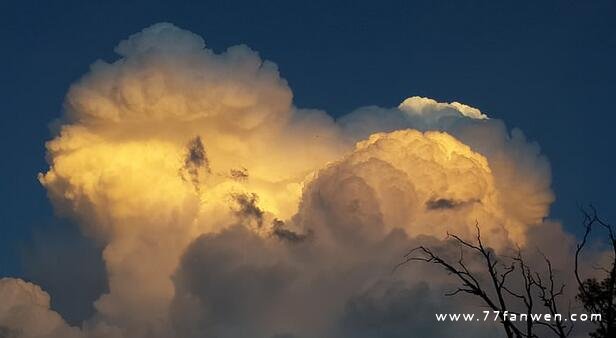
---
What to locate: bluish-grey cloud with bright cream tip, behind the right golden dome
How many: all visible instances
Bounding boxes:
[339,97,554,239]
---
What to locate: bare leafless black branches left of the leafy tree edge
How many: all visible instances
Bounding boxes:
[394,224,573,338]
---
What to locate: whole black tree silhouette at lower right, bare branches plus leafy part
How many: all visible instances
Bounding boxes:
[394,206,616,338]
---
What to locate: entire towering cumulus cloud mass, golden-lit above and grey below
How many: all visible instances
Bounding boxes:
[0,23,588,338]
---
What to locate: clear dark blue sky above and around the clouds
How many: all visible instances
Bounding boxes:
[0,0,616,276]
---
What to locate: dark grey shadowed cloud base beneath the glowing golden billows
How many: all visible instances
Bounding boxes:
[171,226,506,338]
